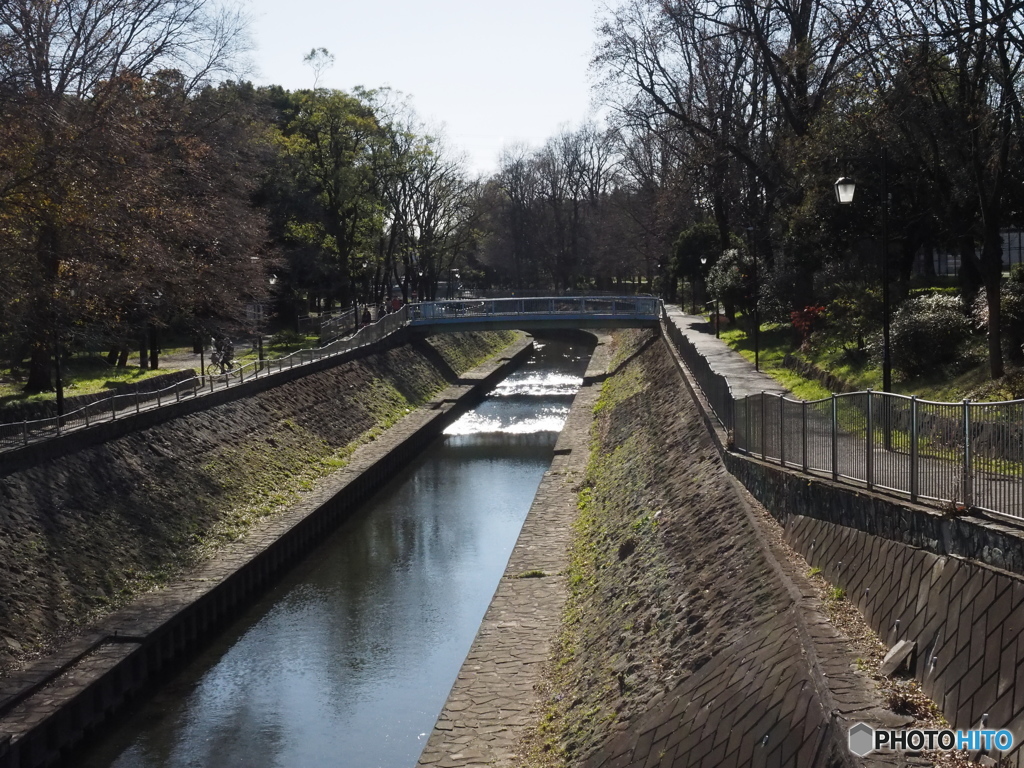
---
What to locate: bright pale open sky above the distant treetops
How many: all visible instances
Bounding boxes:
[247,0,602,173]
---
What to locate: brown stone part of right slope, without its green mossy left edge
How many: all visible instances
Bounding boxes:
[567,333,907,768]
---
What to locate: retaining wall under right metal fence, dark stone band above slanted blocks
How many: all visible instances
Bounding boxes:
[667,321,1024,766]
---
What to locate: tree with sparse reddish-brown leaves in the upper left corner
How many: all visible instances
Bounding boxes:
[0,0,251,391]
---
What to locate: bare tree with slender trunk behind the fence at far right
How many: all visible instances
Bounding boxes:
[869,0,1024,378]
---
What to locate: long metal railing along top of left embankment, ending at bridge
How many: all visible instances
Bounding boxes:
[0,307,409,451]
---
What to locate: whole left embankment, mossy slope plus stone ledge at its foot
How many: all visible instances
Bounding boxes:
[0,334,529,768]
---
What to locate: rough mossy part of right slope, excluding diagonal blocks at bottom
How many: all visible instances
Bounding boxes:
[530,332,847,765]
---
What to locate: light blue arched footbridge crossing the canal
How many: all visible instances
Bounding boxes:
[409,296,662,333]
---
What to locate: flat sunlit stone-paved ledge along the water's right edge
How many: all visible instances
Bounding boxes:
[419,337,609,768]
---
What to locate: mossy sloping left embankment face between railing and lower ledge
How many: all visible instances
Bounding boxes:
[0,333,515,670]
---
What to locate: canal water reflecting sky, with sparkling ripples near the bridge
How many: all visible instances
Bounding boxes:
[73,341,590,768]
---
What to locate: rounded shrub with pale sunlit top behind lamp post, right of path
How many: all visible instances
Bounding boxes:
[884,294,971,376]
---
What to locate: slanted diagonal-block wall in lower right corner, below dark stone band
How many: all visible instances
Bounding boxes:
[786,515,1024,765]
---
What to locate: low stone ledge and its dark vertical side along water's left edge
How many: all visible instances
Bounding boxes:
[0,340,532,768]
